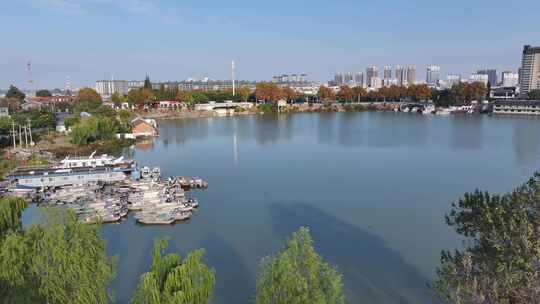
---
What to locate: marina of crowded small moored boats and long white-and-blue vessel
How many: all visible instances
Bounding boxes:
[7,153,208,225]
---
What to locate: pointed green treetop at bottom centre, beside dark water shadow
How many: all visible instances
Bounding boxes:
[256,227,345,304]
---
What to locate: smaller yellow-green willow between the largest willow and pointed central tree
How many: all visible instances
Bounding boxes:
[132,240,215,304]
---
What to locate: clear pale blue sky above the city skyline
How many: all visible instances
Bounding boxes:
[0,0,540,88]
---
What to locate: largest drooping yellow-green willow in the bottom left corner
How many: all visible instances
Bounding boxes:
[0,208,115,304]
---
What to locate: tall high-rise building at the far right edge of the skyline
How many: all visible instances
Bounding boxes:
[520,45,540,95]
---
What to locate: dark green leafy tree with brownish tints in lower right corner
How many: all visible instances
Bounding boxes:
[434,173,540,304]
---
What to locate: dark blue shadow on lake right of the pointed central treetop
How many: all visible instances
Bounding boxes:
[268,203,435,304]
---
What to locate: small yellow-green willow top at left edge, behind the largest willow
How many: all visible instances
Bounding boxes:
[0,197,26,242]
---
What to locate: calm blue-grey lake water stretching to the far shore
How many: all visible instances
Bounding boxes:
[24,112,540,303]
